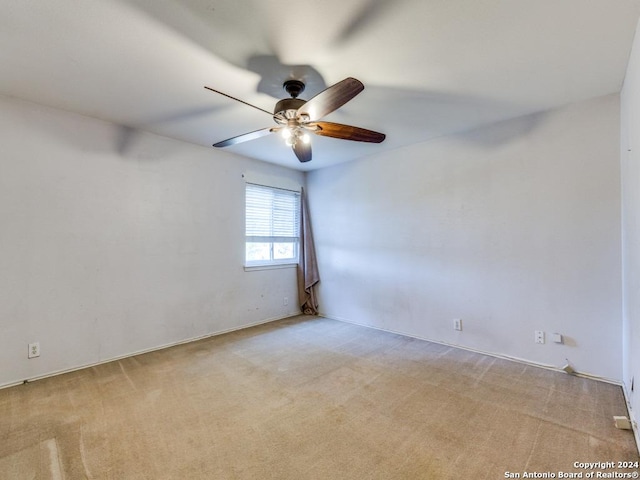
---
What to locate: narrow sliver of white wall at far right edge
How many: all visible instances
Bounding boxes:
[620,15,640,436]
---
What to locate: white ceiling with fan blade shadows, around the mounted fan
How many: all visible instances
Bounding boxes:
[0,0,640,170]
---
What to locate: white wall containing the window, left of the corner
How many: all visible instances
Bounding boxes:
[0,97,304,385]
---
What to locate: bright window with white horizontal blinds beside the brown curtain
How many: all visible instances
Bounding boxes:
[245,183,300,267]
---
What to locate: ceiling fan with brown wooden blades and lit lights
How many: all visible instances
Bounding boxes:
[204,77,385,162]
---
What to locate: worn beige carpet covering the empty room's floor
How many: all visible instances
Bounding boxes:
[0,317,640,480]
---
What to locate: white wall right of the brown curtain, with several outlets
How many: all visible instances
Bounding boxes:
[307,95,622,380]
